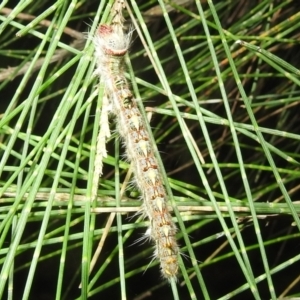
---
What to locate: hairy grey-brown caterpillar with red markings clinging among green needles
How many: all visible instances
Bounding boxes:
[93,2,179,279]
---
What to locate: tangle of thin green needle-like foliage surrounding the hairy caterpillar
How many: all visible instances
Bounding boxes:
[0,0,300,299]
